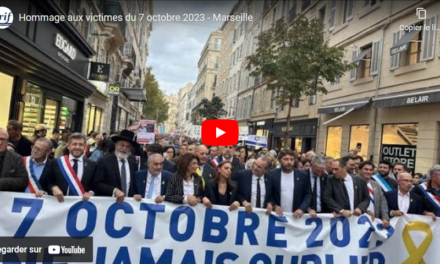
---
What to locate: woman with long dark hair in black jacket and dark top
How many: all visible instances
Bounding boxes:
[202,161,240,211]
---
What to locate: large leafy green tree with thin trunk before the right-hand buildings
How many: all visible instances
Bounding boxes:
[246,16,353,147]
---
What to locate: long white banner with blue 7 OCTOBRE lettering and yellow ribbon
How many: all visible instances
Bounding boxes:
[0,192,440,264]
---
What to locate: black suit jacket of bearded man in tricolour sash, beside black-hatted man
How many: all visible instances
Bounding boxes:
[47,156,96,196]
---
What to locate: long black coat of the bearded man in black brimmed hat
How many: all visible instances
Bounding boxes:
[94,154,138,197]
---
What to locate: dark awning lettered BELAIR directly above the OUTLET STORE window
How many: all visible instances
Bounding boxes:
[373,86,440,108]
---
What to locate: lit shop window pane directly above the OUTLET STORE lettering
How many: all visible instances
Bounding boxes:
[382,124,419,146]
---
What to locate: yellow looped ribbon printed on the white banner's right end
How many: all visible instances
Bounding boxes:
[402,221,432,264]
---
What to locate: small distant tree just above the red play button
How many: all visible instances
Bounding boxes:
[192,96,227,124]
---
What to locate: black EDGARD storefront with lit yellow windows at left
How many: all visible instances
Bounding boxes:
[0,1,95,133]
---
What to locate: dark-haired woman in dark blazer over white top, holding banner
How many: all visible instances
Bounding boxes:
[165,153,203,206]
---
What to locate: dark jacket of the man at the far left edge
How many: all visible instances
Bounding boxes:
[0,151,29,192]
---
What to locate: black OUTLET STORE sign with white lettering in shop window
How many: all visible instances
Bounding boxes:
[381,144,417,172]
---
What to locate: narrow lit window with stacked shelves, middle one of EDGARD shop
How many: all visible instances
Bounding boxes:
[22,83,43,137]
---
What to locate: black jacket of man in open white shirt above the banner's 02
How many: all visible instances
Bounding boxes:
[323,175,370,213]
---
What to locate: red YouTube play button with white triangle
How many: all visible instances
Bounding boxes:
[202,119,238,146]
